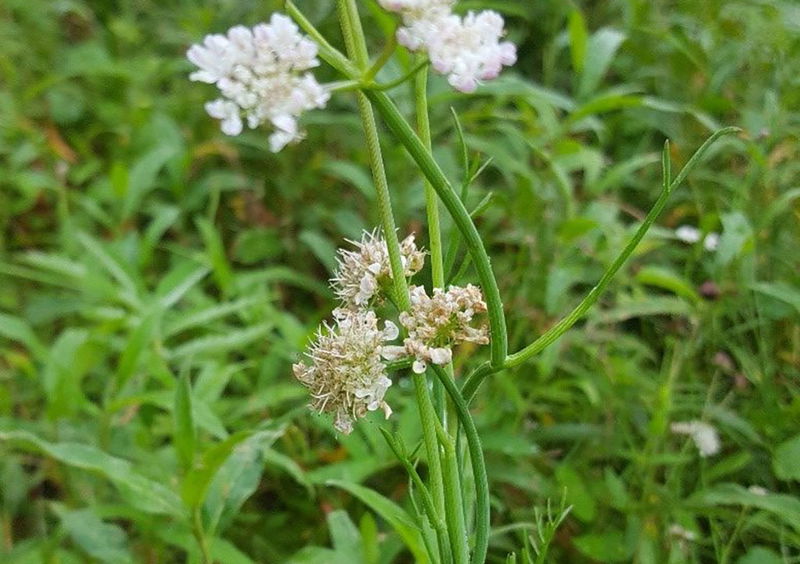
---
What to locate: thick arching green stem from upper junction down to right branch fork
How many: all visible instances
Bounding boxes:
[365,90,508,367]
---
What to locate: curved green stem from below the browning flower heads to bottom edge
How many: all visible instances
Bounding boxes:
[432,365,490,563]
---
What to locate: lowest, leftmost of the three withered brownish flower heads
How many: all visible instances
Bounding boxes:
[292,310,399,434]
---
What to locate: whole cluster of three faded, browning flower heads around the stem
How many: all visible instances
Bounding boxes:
[292,231,489,434]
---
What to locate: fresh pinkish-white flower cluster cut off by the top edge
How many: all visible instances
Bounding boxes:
[379,0,517,92]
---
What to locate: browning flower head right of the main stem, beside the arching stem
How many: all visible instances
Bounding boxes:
[384,284,489,373]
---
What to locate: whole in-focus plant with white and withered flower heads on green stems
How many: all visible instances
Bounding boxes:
[188,0,731,563]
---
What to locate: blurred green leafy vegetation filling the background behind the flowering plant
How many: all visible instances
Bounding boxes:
[0,0,800,564]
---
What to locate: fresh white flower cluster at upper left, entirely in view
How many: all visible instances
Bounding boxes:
[186,14,330,152]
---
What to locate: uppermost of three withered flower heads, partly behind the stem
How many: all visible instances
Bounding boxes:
[331,230,425,309]
